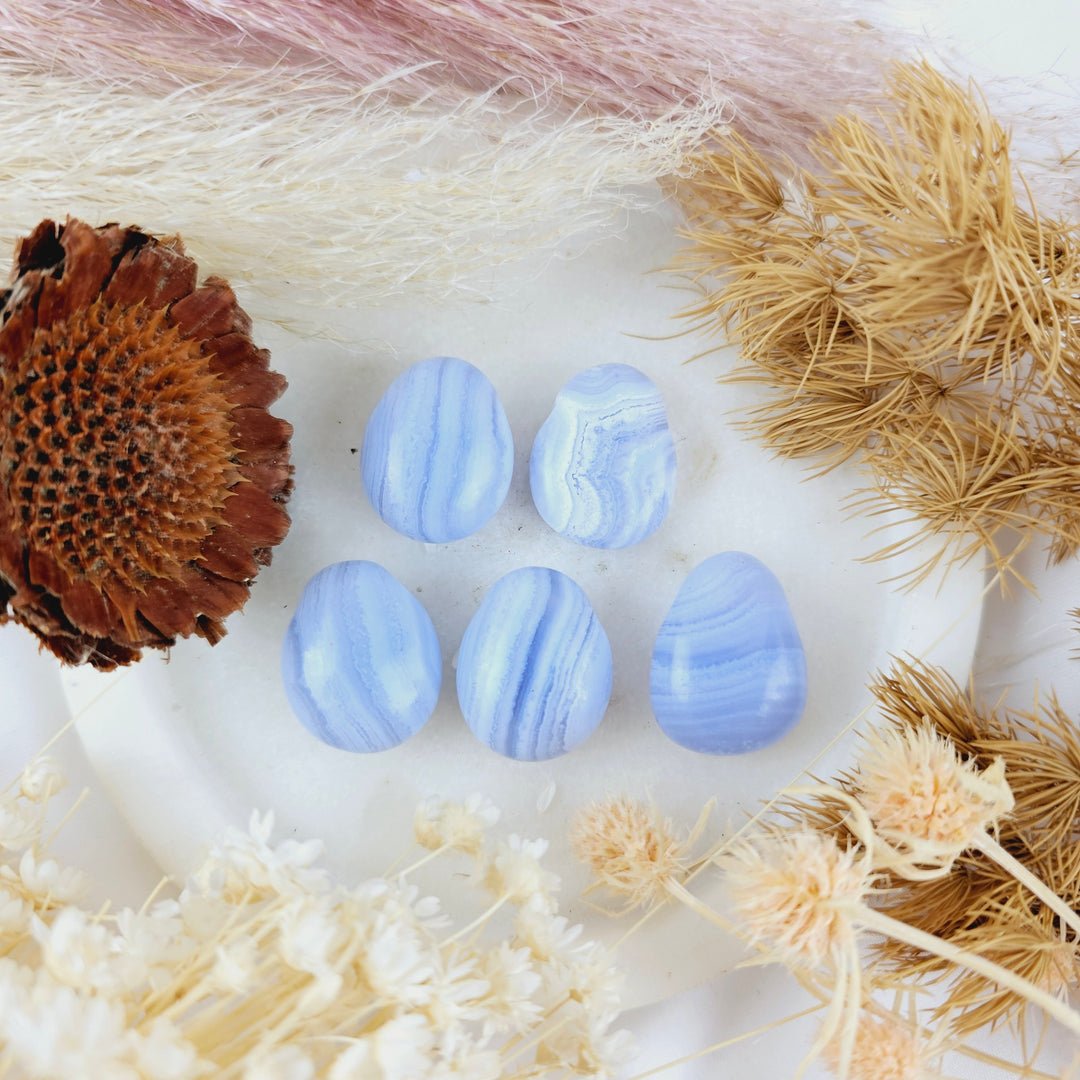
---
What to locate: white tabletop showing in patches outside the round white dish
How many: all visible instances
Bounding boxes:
[0,0,1080,1080]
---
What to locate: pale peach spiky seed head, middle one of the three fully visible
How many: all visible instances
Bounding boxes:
[719,831,870,968]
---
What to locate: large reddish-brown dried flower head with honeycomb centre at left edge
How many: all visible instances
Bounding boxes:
[0,219,292,670]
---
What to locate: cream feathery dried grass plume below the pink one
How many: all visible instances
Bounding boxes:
[0,59,724,318]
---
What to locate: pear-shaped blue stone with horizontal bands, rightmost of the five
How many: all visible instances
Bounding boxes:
[649,551,807,754]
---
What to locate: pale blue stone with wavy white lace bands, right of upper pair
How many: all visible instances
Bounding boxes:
[529,364,675,548]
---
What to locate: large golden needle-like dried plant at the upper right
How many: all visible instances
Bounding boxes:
[673,63,1080,583]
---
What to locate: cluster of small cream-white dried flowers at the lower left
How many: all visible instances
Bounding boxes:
[0,762,629,1080]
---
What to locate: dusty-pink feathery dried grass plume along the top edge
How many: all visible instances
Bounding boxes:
[0,0,910,154]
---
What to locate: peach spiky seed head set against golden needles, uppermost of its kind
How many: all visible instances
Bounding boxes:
[854,723,1013,865]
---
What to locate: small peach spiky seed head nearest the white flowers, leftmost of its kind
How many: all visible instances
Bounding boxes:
[570,796,688,907]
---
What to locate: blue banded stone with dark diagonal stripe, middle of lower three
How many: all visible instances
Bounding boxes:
[458,566,611,761]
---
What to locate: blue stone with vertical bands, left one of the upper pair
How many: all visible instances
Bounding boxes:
[361,356,514,543]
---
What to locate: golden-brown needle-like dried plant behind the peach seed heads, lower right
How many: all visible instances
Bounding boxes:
[782,660,1080,1037]
